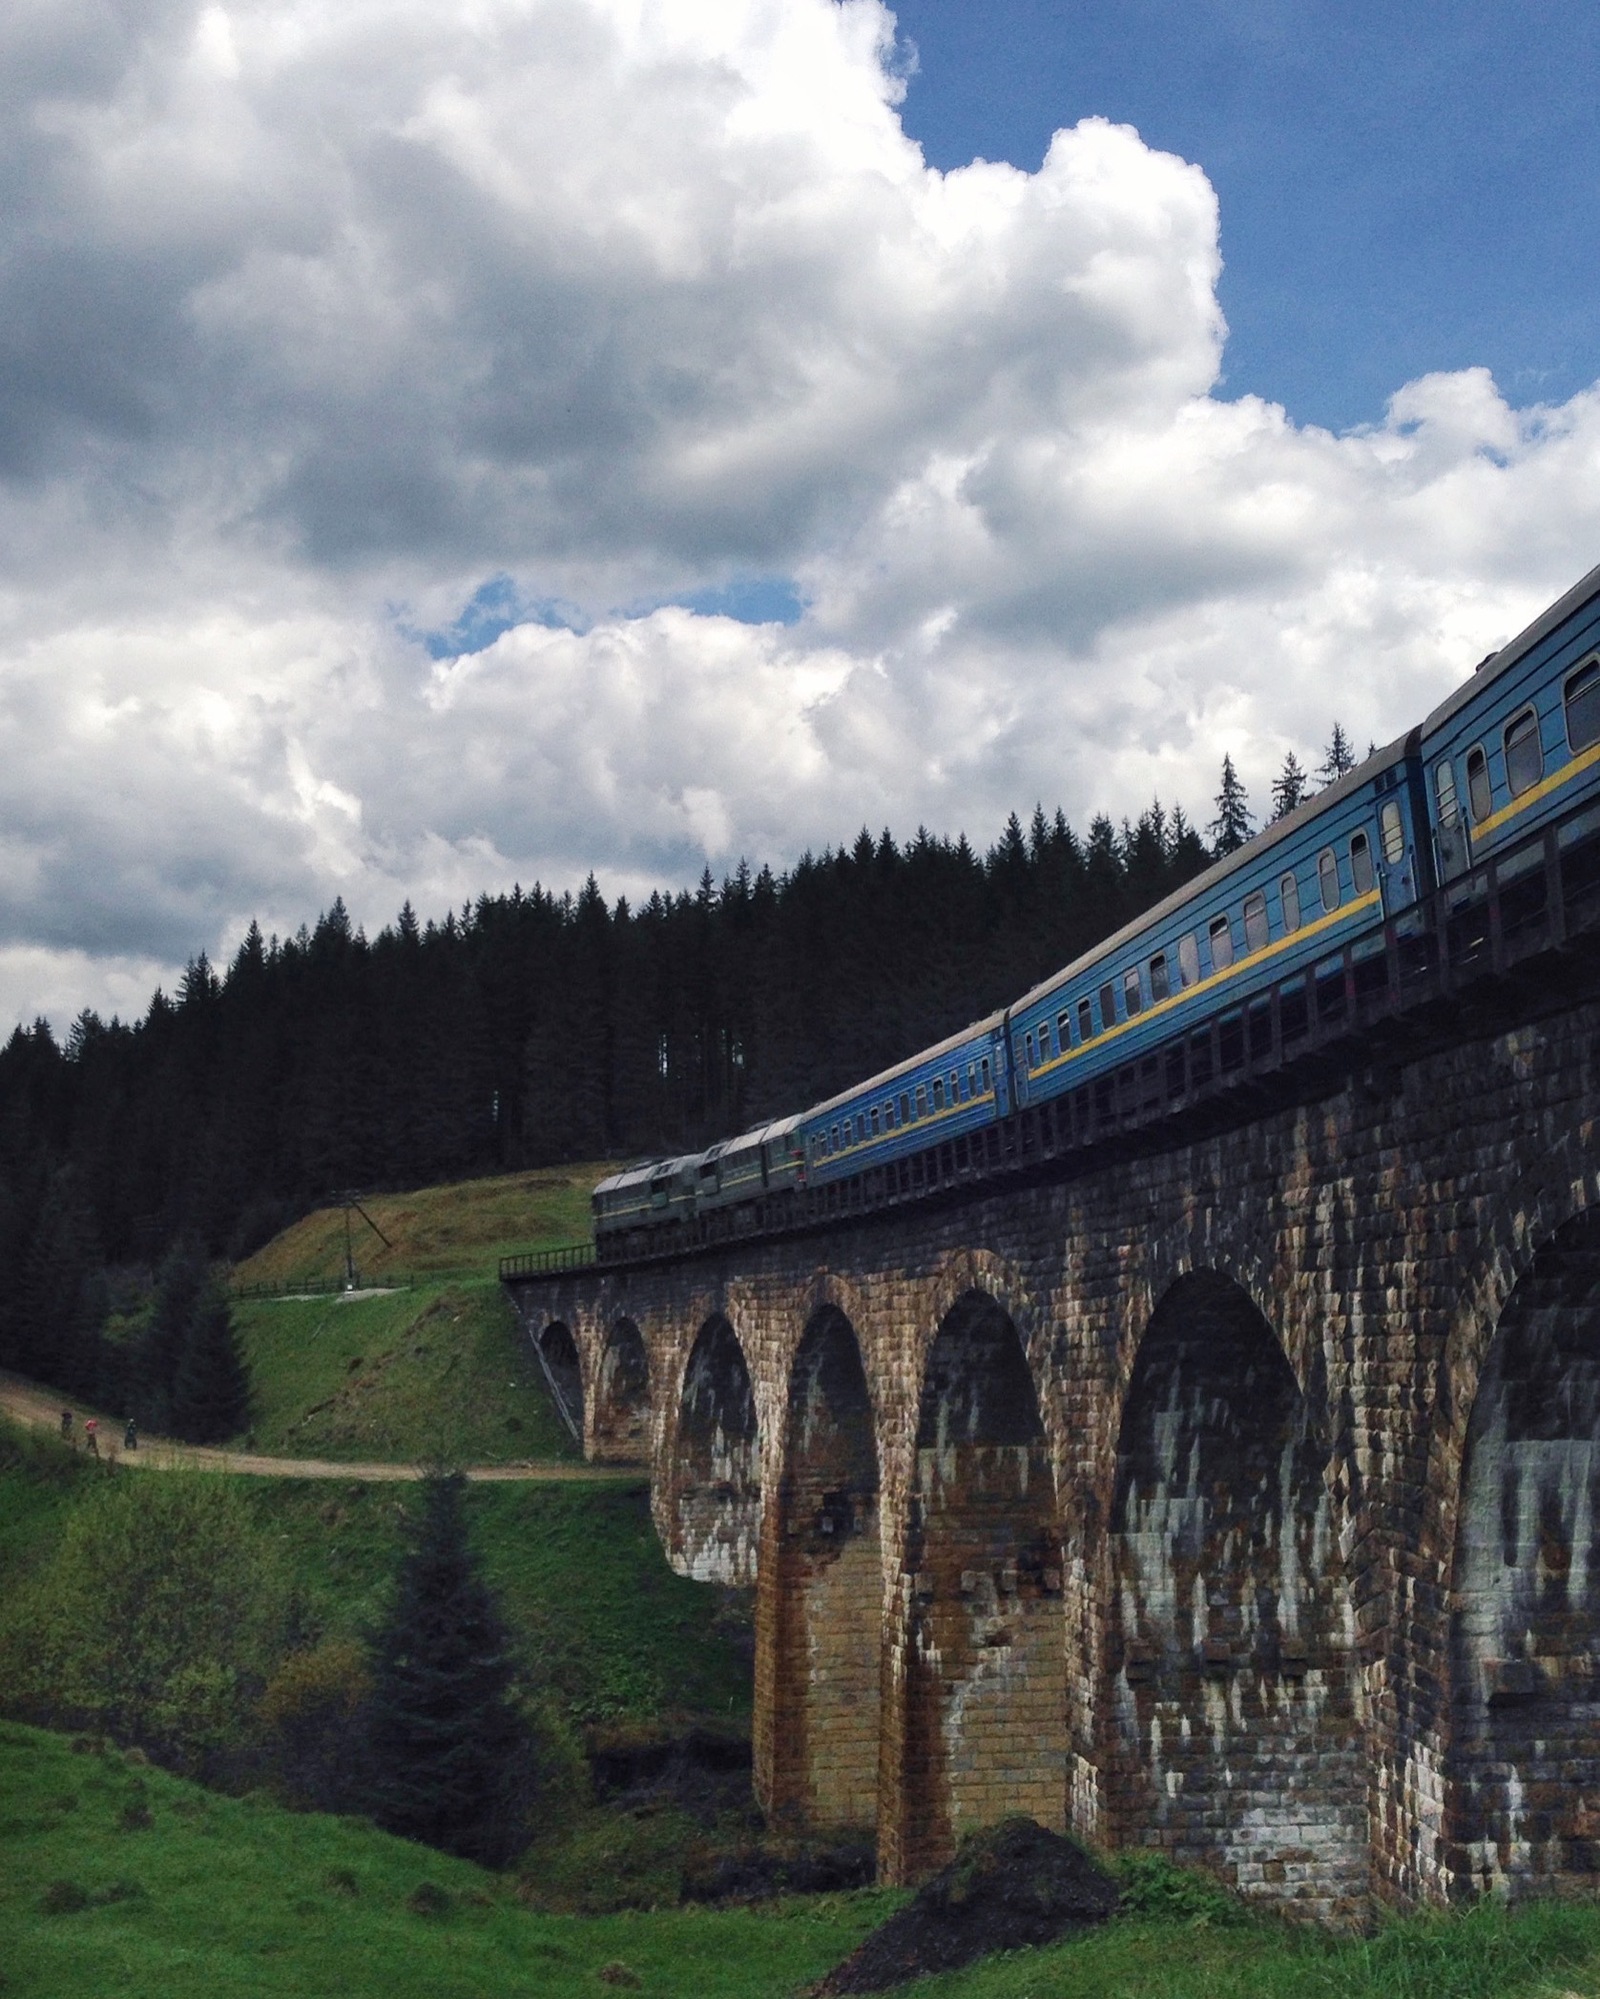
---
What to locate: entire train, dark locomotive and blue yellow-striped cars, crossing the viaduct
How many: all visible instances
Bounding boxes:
[592,566,1600,1261]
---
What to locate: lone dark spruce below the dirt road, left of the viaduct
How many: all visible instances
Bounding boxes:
[368,1473,532,1867]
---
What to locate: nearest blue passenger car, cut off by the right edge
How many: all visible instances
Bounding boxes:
[1422,568,1600,882]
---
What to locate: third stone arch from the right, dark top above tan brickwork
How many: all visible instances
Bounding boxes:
[894,1289,1066,1879]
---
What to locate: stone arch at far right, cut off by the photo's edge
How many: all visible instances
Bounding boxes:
[1446,1213,1600,1897]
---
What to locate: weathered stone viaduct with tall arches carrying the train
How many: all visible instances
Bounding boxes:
[512,1000,1600,1921]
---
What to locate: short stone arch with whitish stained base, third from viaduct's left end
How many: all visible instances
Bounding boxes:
[672,1313,762,1583]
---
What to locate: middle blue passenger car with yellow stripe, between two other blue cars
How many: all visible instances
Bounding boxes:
[1010,732,1432,1103]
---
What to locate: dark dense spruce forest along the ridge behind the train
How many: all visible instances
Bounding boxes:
[0,806,1210,1379]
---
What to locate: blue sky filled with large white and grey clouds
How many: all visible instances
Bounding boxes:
[0,0,1600,1023]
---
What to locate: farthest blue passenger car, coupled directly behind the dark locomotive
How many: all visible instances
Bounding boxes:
[800,1013,1010,1187]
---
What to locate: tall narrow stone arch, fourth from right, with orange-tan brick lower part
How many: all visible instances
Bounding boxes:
[766,1305,884,1827]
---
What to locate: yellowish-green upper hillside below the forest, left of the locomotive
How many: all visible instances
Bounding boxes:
[234,1161,612,1285]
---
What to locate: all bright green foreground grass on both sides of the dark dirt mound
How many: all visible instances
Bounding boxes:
[0,1727,1600,1999]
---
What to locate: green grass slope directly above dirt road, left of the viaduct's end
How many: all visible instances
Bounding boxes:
[234,1277,578,1463]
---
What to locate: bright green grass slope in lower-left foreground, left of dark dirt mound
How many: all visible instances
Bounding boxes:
[0,1727,878,1999]
